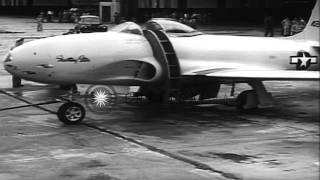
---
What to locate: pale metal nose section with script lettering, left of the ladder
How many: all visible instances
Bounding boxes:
[5,32,162,85]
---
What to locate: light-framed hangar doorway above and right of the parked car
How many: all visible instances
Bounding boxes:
[99,0,120,23]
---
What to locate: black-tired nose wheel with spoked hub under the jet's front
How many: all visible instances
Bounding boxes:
[57,102,86,125]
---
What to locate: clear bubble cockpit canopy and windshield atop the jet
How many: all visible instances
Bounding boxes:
[110,18,203,36]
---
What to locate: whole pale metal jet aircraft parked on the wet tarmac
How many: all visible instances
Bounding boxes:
[4,0,320,124]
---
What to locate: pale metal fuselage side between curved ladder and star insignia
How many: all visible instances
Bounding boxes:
[171,35,319,76]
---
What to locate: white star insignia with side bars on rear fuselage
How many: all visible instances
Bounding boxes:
[290,51,318,70]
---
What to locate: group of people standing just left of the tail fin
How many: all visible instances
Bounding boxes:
[281,17,306,36]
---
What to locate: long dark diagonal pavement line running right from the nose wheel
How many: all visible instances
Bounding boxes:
[82,122,242,180]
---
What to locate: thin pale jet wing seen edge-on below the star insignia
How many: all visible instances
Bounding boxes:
[187,69,320,80]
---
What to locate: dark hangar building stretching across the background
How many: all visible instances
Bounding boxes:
[0,0,315,24]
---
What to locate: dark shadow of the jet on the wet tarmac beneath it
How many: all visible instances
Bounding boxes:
[1,85,318,139]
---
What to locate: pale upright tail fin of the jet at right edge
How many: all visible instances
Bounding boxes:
[292,0,320,43]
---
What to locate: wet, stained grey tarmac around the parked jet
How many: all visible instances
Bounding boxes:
[0,16,319,180]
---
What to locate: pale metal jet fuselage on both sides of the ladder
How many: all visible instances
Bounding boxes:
[5,32,319,85]
